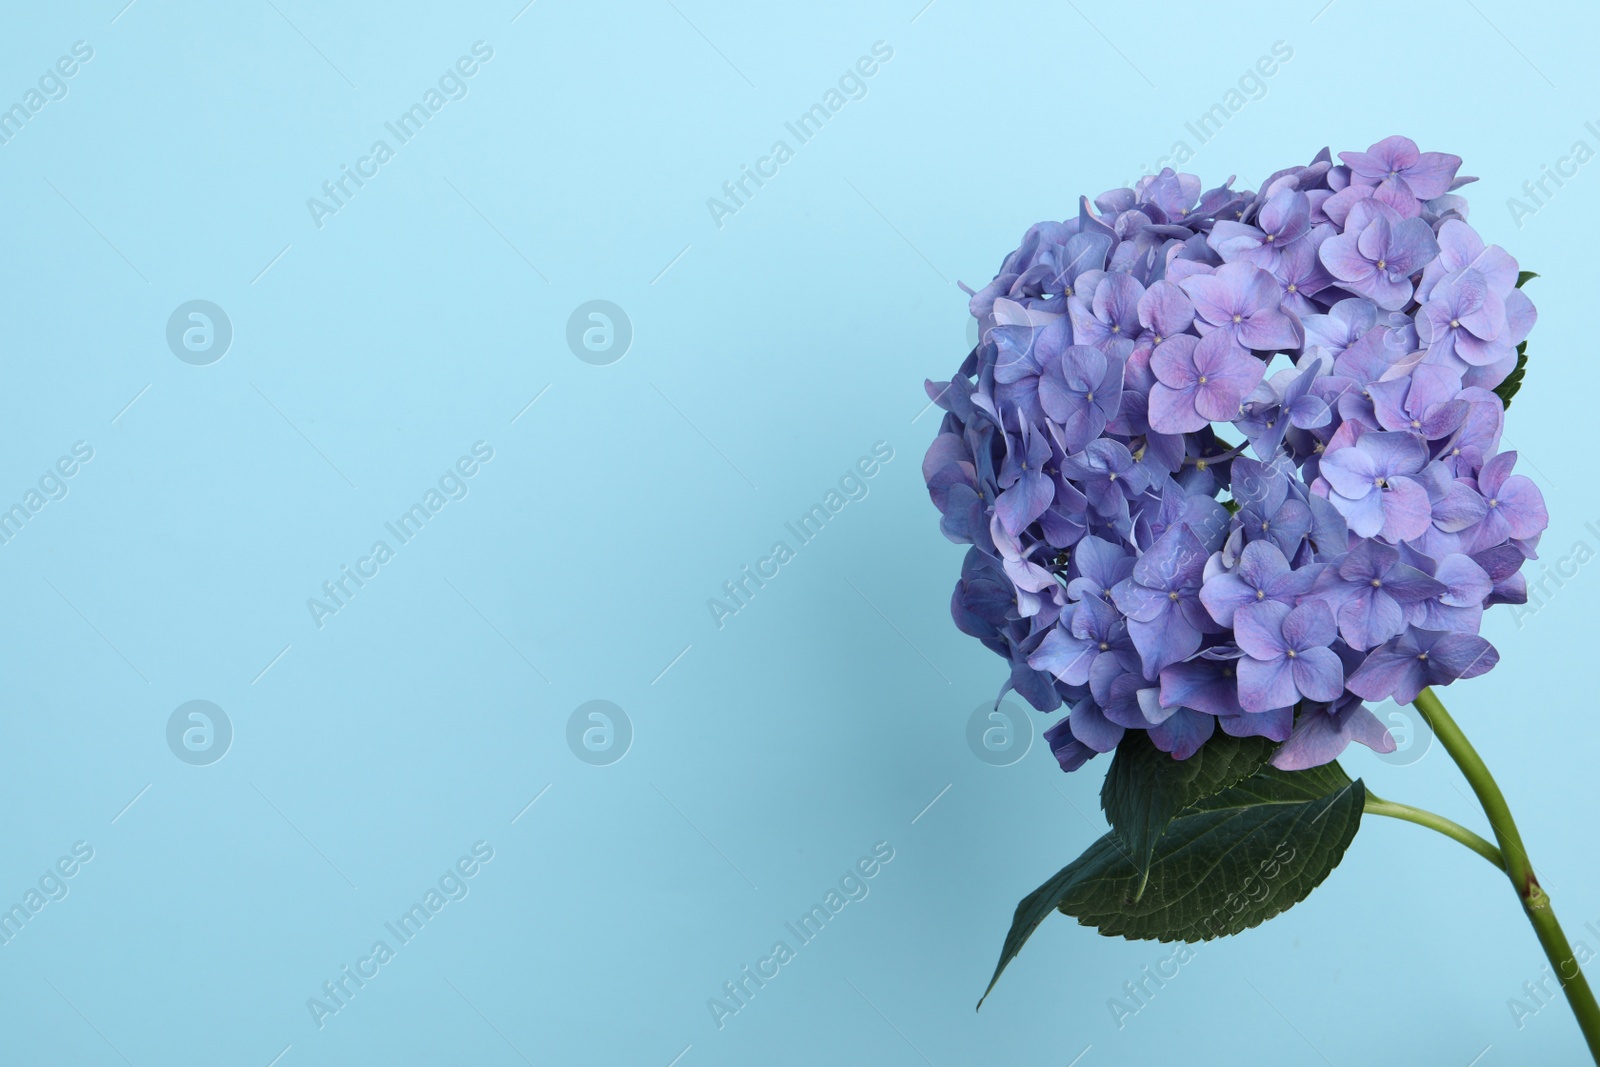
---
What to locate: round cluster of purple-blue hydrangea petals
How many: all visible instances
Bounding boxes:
[923,138,1549,771]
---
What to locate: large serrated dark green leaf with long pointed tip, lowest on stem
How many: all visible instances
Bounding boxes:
[978,763,1366,1008]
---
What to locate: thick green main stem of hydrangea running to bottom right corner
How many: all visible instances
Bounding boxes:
[1411,689,1600,1064]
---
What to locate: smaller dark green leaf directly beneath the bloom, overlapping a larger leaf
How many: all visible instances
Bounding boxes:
[1101,729,1277,901]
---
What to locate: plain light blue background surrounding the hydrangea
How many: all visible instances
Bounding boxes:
[0,0,1600,1067]
